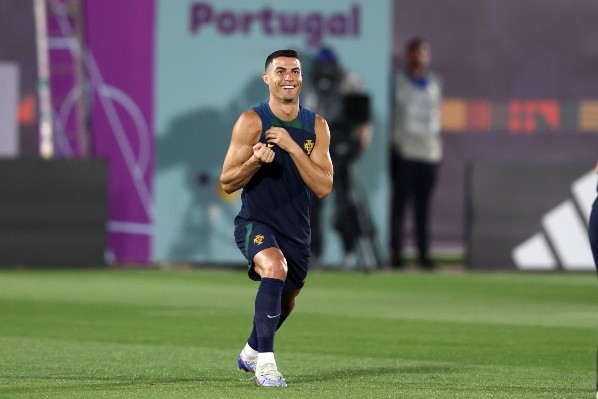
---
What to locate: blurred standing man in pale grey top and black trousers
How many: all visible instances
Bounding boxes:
[390,38,442,269]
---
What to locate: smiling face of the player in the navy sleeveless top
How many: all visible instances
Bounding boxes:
[262,57,303,103]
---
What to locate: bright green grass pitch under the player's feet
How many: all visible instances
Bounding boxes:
[0,270,598,399]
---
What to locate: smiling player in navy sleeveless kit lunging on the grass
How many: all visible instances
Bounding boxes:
[220,50,333,387]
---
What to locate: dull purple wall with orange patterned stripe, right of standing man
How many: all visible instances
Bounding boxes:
[393,0,598,252]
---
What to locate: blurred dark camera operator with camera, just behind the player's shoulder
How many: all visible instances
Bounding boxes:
[301,47,377,269]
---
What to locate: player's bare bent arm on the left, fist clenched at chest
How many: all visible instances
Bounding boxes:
[220,111,274,194]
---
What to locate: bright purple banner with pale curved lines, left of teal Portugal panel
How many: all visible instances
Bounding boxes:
[84,0,155,263]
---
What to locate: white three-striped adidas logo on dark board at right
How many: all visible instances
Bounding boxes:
[511,170,596,271]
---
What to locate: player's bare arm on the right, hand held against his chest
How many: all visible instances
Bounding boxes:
[266,115,334,198]
